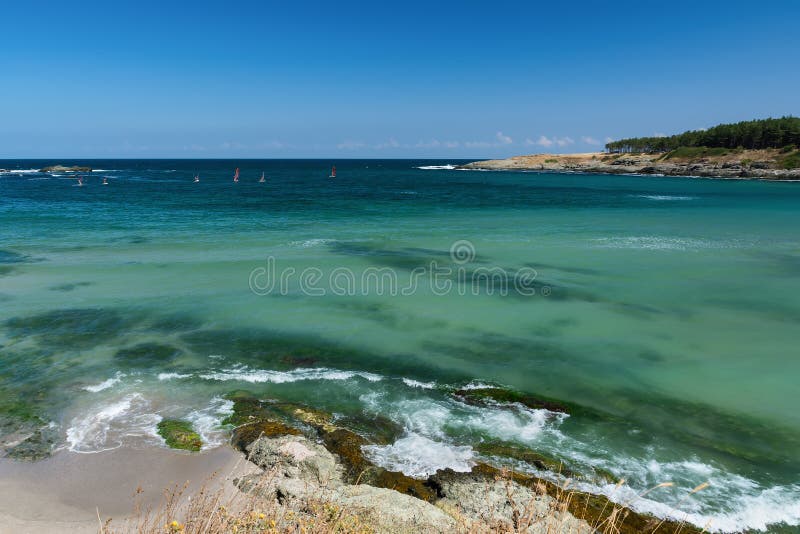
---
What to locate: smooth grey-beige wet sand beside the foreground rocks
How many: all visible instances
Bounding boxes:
[0,447,255,534]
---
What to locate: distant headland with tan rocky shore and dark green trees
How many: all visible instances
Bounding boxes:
[460,117,800,180]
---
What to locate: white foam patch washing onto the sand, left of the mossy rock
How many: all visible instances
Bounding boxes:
[67,393,161,453]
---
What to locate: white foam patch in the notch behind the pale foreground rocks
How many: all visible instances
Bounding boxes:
[362,433,475,478]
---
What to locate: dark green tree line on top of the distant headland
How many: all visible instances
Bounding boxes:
[606,117,800,152]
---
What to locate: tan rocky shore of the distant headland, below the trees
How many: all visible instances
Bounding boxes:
[457,150,800,181]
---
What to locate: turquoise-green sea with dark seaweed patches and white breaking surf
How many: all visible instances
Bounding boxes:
[0,160,800,531]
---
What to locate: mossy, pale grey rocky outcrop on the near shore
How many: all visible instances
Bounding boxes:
[228,389,699,534]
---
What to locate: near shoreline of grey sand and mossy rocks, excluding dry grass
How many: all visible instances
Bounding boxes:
[0,393,697,534]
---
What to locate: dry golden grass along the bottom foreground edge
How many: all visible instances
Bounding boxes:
[98,458,708,534]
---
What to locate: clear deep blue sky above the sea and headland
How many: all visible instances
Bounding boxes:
[0,0,800,158]
